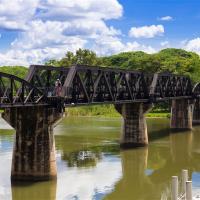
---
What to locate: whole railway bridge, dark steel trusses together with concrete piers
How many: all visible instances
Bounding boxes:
[0,65,200,181]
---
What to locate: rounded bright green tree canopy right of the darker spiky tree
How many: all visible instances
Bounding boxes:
[100,48,200,81]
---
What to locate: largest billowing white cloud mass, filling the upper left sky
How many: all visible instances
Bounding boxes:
[0,0,123,65]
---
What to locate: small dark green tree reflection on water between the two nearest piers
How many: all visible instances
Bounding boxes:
[62,145,119,167]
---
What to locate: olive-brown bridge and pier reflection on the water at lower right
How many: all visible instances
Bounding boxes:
[105,132,200,200]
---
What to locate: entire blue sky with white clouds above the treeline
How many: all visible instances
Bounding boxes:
[0,0,200,65]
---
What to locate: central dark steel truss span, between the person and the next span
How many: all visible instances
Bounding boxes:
[63,66,153,104]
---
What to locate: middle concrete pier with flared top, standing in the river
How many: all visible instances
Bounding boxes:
[115,103,152,148]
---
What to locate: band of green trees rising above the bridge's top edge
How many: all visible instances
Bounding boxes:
[46,48,200,81]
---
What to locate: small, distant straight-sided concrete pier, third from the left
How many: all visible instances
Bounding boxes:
[171,99,193,130]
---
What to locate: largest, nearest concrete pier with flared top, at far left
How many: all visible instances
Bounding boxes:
[2,106,62,181]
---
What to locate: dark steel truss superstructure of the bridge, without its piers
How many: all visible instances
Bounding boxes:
[0,65,200,108]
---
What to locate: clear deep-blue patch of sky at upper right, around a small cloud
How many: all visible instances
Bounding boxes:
[120,0,200,40]
